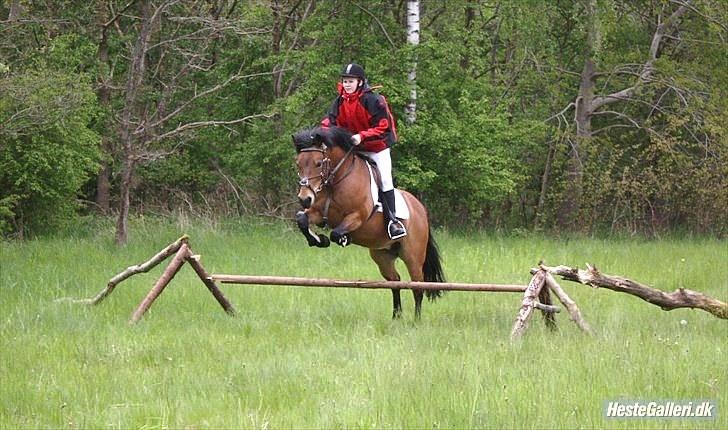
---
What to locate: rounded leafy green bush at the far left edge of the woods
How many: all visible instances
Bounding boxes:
[0,34,100,235]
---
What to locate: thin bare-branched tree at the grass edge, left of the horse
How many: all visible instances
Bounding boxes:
[109,0,270,244]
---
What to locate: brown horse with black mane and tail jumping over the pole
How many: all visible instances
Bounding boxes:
[293,127,444,318]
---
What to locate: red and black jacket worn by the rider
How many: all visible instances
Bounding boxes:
[321,83,397,152]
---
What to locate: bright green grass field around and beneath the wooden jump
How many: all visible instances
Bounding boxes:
[0,219,728,429]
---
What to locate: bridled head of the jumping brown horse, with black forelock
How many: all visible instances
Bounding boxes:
[292,127,352,208]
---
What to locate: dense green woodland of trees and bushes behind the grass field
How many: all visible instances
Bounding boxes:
[0,0,728,243]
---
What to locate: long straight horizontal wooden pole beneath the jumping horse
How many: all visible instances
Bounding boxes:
[210,274,526,293]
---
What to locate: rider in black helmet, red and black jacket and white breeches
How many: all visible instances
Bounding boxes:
[321,63,407,240]
